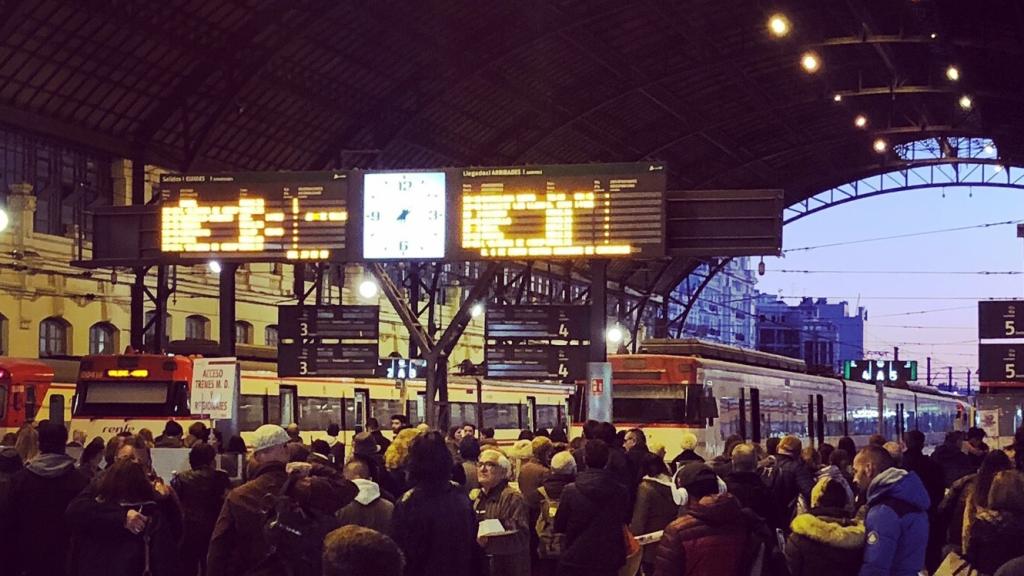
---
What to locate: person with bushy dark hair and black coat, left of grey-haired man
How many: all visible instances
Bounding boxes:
[391,431,482,576]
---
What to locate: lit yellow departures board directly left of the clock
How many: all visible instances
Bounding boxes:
[160,172,349,260]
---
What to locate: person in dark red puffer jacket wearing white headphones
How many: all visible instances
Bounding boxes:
[654,462,771,576]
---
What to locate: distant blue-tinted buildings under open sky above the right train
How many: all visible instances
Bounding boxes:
[757,294,867,373]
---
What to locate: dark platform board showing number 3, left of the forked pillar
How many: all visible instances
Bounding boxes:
[278,305,380,376]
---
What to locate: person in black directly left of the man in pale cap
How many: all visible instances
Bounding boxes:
[171,443,231,576]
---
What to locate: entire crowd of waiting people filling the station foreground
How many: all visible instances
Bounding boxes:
[6,415,1024,576]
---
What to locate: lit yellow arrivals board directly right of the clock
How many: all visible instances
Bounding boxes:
[460,163,665,258]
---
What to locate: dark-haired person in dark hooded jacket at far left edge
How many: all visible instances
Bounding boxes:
[0,420,88,576]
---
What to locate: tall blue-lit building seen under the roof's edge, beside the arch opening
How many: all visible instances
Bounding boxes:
[669,258,758,348]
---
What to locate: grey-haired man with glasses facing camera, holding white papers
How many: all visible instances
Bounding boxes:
[473,450,530,576]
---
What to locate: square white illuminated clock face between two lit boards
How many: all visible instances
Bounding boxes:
[362,172,447,259]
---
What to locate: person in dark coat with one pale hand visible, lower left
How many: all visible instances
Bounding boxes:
[66,457,183,576]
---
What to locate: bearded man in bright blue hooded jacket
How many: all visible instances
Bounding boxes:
[853,446,931,576]
